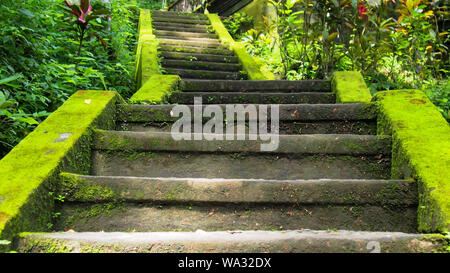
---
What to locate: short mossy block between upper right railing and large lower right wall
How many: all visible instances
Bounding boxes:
[331,71,372,103]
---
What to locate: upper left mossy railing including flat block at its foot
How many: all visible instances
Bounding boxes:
[130,9,180,104]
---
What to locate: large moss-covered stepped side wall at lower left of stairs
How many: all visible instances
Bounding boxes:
[0,91,122,248]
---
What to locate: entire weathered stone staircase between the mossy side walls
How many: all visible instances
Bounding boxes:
[14,12,446,252]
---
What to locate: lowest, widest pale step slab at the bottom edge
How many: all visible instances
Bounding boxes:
[18,230,447,253]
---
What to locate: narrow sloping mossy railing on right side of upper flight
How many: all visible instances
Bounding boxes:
[206,13,275,80]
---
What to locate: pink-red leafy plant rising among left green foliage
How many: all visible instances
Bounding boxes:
[63,0,109,56]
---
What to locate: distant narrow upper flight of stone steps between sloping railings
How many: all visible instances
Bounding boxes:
[152,11,246,80]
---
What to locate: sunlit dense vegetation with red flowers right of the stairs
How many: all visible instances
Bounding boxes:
[224,0,450,120]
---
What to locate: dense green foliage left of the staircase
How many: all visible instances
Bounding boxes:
[0,0,138,158]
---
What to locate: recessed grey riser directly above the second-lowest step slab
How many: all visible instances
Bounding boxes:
[91,150,390,180]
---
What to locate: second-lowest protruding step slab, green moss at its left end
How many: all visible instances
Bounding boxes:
[60,173,418,207]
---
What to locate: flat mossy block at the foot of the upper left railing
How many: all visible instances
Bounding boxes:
[130,75,181,104]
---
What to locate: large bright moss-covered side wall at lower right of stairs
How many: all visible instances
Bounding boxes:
[374,90,450,232]
